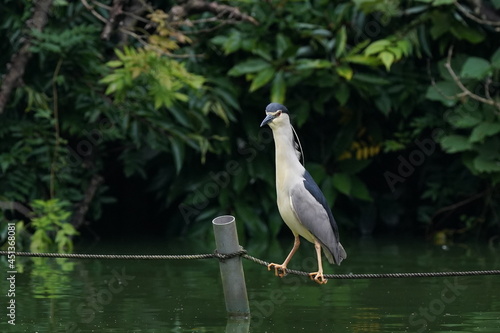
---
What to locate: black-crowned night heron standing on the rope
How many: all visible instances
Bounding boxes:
[260,103,347,284]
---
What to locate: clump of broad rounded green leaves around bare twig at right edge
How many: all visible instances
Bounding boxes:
[427,54,500,185]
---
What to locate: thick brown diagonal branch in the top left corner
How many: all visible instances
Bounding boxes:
[0,0,52,114]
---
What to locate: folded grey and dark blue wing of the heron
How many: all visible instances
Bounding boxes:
[290,170,347,265]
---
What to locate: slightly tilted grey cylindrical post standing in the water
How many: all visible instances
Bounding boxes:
[212,215,250,318]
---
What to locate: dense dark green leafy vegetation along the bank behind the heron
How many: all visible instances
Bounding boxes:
[0,0,500,251]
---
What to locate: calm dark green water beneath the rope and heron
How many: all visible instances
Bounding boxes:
[0,238,500,333]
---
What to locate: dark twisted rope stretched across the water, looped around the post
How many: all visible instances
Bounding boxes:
[0,250,500,280]
